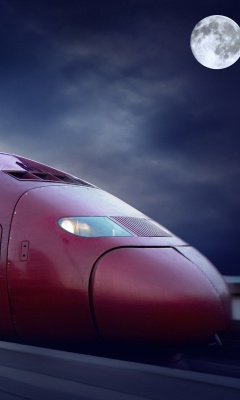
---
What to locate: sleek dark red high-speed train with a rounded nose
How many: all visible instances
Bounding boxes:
[0,153,230,344]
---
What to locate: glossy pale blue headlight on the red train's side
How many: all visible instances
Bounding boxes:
[58,217,133,237]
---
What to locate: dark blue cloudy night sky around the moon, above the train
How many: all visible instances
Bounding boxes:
[0,0,240,275]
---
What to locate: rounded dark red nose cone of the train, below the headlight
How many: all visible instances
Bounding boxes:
[90,248,229,343]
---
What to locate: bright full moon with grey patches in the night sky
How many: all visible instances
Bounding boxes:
[190,15,240,69]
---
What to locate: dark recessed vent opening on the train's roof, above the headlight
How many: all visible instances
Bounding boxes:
[4,171,92,187]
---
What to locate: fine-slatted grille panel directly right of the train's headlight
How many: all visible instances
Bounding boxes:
[111,217,172,237]
